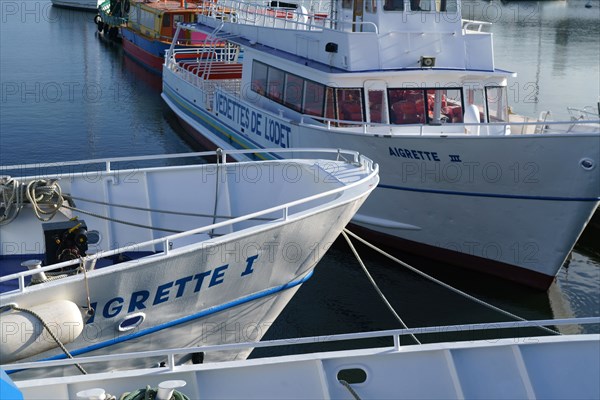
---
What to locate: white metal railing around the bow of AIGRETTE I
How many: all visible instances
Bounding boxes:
[0,148,379,297]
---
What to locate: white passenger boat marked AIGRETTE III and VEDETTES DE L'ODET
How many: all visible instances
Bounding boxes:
[162,0,600,289]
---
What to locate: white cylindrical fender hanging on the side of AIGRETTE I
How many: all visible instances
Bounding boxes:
[0,300,84,363]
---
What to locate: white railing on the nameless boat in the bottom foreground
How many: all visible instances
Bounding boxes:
[0,317,600,371]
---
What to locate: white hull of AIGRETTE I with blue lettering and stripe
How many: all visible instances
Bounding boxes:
[0,155,377,379]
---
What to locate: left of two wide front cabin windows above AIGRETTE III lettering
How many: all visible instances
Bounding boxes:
[388,89,425,124]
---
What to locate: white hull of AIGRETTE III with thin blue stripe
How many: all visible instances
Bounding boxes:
[163,69,600,289]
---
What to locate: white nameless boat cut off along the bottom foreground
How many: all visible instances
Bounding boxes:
[3,318,600,400]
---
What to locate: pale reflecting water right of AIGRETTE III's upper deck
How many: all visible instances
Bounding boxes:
[463,0,600,118]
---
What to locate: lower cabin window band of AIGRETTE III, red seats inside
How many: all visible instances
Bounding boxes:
[245,52,508,126]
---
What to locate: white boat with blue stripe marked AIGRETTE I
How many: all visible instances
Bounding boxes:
[0,149,378,377]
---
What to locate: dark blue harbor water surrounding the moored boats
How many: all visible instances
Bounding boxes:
[0,0,600,350]
